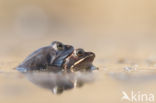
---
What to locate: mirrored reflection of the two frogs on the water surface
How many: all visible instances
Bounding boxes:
[20,71,95,94]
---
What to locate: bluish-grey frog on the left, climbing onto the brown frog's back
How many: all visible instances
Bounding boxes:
[16,41,74,72]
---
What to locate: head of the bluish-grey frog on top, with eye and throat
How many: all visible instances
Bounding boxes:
[51,41,74,67]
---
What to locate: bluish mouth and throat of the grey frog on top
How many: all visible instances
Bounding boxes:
[53,45,74,67]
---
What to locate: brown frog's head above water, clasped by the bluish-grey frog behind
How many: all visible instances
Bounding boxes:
[63,48,97,72]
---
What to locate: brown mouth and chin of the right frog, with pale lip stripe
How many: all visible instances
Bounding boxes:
[70,52,95,72]
